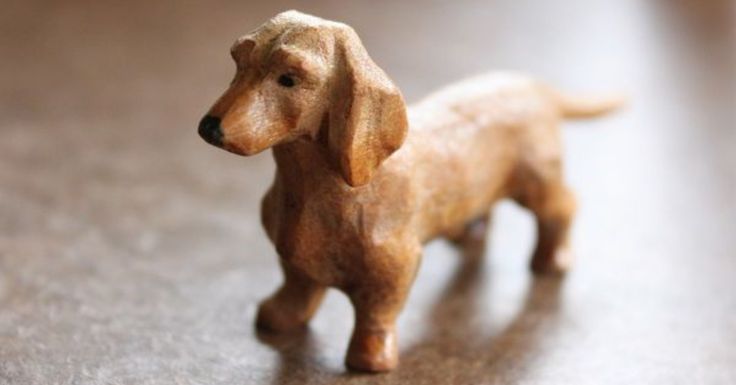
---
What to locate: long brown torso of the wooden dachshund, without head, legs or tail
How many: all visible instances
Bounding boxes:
[262,74,560,287]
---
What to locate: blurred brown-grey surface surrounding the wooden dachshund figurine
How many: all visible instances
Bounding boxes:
[0,0,736,384]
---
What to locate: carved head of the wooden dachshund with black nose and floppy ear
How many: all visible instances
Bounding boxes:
[199,11,408,186]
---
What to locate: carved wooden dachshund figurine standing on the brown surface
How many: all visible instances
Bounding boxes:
[199,11,619,371]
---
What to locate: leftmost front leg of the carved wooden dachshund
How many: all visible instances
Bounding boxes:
[256,264,326,332]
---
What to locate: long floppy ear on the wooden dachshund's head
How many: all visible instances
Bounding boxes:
[328,30,408,187]
